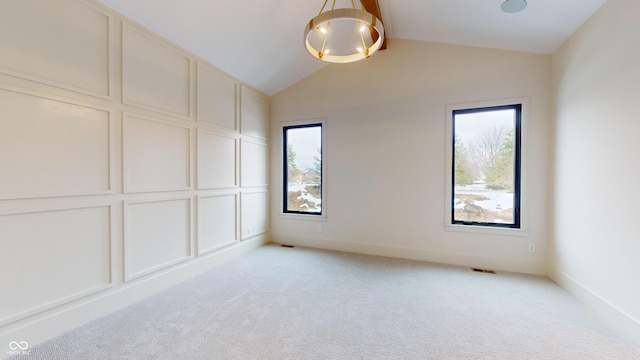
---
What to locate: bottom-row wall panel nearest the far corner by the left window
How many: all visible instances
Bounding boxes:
[240,190,269,239]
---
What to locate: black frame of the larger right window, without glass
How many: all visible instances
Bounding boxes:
[450,103,523,229]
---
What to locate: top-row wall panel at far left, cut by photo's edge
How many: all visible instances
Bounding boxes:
[0,0,109,96]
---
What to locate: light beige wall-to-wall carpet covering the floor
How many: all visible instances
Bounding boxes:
[12,245,640,360]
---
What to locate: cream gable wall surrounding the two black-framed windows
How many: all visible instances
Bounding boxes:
[271,39,551,274]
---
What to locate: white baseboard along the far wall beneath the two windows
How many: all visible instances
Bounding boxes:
[271,234,547,275]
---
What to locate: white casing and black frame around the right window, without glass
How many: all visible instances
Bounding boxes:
[444,97,529,236]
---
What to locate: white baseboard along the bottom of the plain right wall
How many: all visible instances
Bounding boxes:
[549,268,640,345]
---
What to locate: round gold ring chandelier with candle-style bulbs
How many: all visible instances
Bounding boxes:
[304,0,384,63]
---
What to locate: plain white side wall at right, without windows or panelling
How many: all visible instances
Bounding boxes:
[550,0,640,343]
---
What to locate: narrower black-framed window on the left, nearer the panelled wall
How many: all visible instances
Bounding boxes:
[282,123,323,215]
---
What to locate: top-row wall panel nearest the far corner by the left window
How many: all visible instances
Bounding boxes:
[240,86,269,140]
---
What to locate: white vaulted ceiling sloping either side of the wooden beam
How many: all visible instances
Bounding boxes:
[98,0,606,95]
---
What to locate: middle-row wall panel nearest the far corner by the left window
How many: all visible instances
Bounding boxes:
[240,139,269,187]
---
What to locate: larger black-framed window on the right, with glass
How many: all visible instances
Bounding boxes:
[451,104,522,228]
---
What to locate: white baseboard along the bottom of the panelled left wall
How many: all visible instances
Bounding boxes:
[0,235,268,359]
